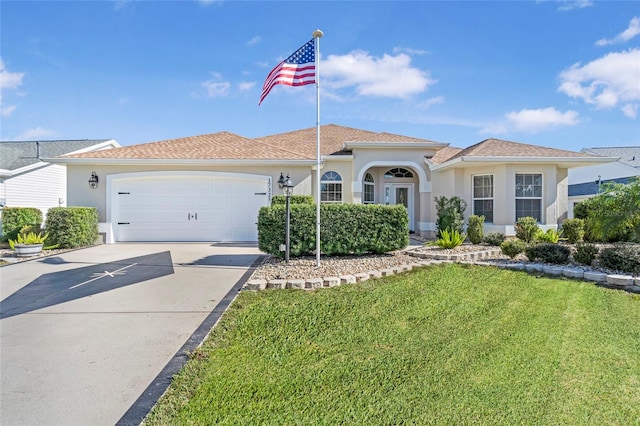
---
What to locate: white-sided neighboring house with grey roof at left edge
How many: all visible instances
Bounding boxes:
[0,139,120,228]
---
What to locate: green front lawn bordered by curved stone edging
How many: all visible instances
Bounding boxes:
[147,265,640,425]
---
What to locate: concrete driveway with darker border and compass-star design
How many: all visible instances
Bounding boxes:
[0,243,260,426]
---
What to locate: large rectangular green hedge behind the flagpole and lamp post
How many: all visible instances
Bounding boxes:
[258,204,409,257]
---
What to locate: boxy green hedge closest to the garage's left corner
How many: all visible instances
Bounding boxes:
[46,207,98,248]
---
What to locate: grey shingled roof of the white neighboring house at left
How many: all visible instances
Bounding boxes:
[0,139,117,171]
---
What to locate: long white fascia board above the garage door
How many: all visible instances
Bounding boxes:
[42,157,316,166]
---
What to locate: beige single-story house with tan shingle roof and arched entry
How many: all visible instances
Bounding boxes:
[49,124,615,243]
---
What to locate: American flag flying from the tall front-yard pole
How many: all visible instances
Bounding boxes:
[258,39,316,105]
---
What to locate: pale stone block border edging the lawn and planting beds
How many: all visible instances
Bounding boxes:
[243,248,640,294]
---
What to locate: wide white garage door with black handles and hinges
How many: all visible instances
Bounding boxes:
[110,172,271,241]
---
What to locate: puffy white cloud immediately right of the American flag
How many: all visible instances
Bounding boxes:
[320,50,436,98]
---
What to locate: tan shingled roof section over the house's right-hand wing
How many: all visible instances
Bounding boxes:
[431,139,616,170]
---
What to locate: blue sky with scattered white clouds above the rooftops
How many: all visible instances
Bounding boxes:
[0,0,640,151]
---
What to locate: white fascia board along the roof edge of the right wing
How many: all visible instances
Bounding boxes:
[425,156,618,171]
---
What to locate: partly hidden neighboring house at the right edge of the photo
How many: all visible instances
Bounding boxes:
[568,146,640,217]
